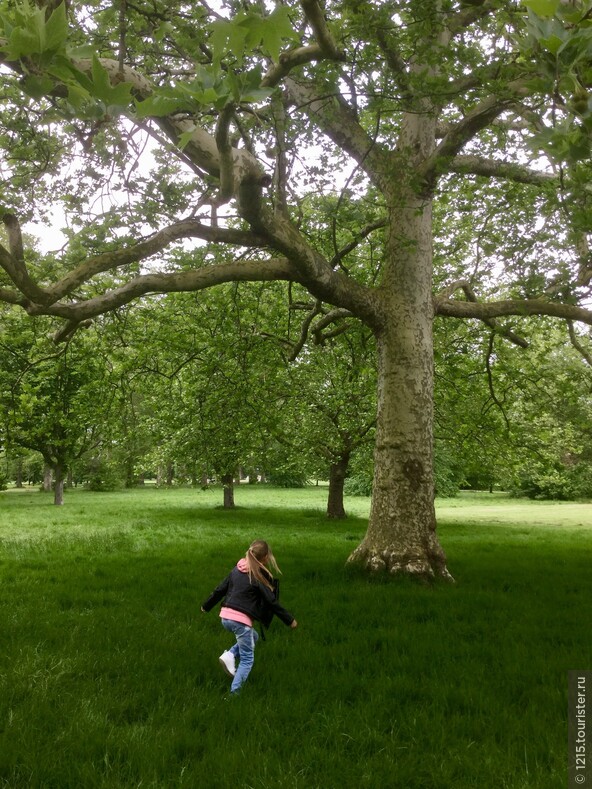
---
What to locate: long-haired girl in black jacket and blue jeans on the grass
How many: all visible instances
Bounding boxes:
[201,540,298,694]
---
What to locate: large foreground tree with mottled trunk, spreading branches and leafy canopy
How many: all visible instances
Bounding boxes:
[0,0,592,578]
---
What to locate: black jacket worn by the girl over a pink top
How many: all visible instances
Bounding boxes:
[202,567,294,627]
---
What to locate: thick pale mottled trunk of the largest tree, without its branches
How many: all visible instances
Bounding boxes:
[349,183,451,579]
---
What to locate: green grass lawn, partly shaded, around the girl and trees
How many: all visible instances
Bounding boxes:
[0,487,592,789]
